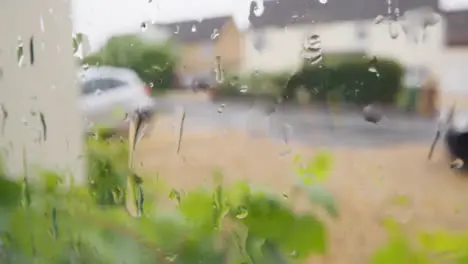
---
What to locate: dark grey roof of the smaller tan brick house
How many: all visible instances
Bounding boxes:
[153,16,231,42]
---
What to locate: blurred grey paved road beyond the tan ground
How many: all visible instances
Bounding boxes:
[155,99,436,147]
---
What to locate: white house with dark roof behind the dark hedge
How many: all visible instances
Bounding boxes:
[243,0,443,75]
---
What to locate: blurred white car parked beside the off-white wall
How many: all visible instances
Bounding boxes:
[78,66,155,132]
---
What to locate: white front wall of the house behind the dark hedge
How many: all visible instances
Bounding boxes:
[244,18,443,79]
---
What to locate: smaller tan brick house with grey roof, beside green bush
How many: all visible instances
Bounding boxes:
[153,16,244,87]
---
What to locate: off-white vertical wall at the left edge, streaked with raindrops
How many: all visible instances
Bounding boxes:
[0,0,85,182]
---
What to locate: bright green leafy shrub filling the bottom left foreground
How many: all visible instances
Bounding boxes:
[0,139,337,264]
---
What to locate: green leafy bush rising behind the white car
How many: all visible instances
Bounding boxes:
[82,35,175,92]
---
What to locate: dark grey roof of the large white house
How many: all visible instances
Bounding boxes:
[249,0,439,28]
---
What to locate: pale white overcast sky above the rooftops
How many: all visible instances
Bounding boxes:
[72,0,468,49]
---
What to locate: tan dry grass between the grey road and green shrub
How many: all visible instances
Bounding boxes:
[134,116,468,264]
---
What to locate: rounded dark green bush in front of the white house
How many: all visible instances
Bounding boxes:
[283,57,403,104]
